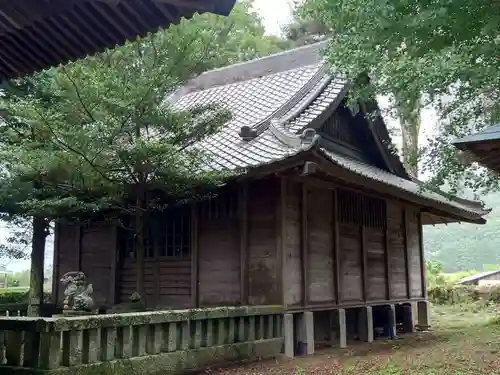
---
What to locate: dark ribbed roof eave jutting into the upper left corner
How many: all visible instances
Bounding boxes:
[0,0,235,79]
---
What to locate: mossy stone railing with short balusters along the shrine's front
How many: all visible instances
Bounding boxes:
[0,306,283,375]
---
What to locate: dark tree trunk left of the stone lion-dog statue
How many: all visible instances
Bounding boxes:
[28,216,47,316]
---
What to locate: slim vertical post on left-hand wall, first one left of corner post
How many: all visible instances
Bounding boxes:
[238,184,248,305]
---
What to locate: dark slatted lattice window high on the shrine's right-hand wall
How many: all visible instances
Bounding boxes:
[337,189,387,229]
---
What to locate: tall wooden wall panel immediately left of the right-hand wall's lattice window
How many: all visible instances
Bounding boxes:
[305,187,335,303]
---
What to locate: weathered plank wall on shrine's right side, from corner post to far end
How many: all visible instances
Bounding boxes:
[283,179,425,310]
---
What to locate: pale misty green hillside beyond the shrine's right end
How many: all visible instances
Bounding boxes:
[424,193,500,272]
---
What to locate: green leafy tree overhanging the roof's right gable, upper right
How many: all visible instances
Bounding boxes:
[302,0,500,183]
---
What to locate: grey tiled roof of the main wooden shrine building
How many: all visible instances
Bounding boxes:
[167,42,489,222]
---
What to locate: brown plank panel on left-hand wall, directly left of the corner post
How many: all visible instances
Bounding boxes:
[248,179,282,305]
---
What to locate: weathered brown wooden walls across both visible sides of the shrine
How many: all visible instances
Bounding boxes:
[55,177,425,310]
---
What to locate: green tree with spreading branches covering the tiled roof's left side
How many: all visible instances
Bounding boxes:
[0,2,290,308]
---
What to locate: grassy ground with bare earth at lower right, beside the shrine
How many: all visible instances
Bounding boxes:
[202,304,500,375]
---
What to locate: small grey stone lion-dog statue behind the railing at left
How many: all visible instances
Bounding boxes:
[61,271,94,312]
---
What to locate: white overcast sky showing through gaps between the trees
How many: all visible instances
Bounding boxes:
[0,0,436,272]
